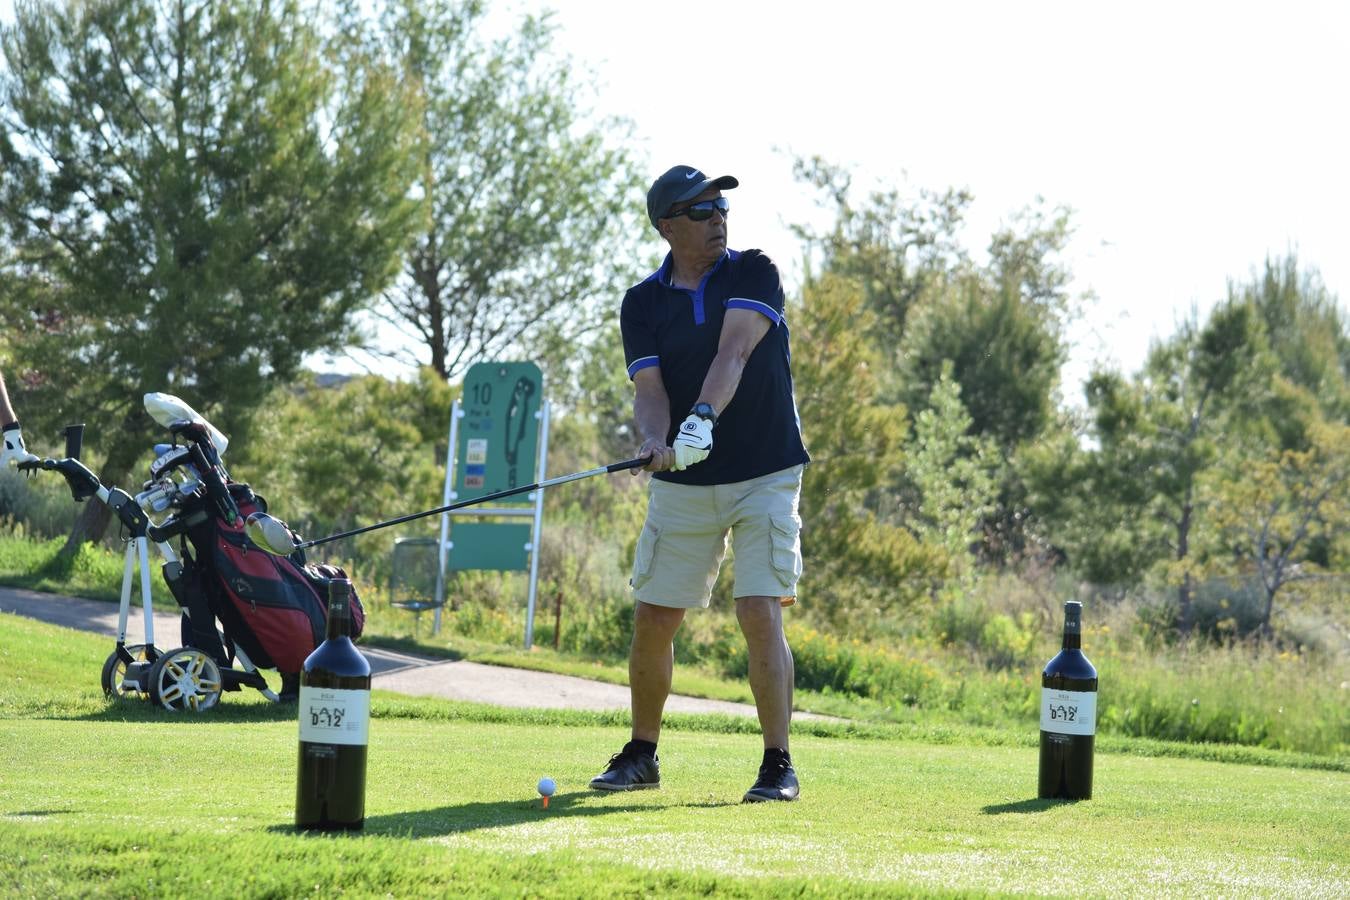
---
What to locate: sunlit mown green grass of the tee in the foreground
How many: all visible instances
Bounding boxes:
[0,615,1350,897]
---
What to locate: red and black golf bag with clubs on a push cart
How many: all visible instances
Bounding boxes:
[19,394,365,711]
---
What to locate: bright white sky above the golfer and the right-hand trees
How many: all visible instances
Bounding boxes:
[529,0,1350,401]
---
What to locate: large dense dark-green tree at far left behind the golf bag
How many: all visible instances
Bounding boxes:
[0,0,416,548]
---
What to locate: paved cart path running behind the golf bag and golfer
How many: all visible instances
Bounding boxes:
[0,587,829,719]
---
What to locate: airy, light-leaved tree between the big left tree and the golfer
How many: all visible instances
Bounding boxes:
[355,0,647,379]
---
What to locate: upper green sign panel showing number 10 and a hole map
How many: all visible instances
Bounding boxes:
[455,363,544,503]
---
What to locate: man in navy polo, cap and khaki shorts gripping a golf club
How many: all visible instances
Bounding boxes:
[590,166,809,801]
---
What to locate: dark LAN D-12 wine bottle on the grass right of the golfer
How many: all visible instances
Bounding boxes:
[1037,600,1096,800]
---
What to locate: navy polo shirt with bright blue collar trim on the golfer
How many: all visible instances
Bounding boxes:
[620,250,810,484]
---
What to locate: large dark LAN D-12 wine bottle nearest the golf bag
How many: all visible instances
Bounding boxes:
[296,579,370,831]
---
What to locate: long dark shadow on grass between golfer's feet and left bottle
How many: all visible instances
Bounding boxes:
[267,791,740,838]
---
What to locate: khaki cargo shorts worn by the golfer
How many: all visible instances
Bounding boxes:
[630,466,802,609]
